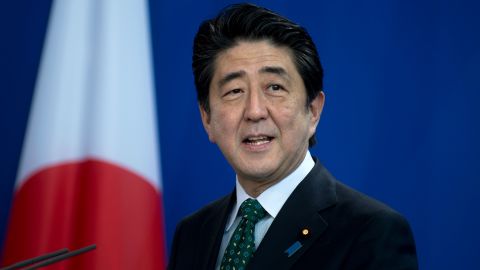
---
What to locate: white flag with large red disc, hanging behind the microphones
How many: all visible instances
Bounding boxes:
[3,0,166,269]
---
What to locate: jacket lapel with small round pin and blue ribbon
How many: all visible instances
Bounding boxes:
[247,161,336,270]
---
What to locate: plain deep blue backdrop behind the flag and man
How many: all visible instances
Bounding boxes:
[0,0,480,269]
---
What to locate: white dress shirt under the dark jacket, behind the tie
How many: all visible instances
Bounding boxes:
[215,151,315,270]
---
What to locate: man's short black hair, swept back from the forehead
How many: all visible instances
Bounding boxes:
[192,4,323,146]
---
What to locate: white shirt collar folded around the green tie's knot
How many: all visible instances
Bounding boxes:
[225,151,315,231]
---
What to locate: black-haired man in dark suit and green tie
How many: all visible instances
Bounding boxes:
[169,4,417,270]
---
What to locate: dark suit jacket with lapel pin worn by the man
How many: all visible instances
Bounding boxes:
[168,161,418,270]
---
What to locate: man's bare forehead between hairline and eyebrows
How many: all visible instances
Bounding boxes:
[213,40,298,80]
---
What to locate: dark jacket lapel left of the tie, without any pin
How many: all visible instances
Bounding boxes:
[193,191,236,269]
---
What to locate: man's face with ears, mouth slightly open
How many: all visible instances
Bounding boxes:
[200,41,324,195]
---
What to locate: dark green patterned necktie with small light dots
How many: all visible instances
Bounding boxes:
[220,199,266,270]
